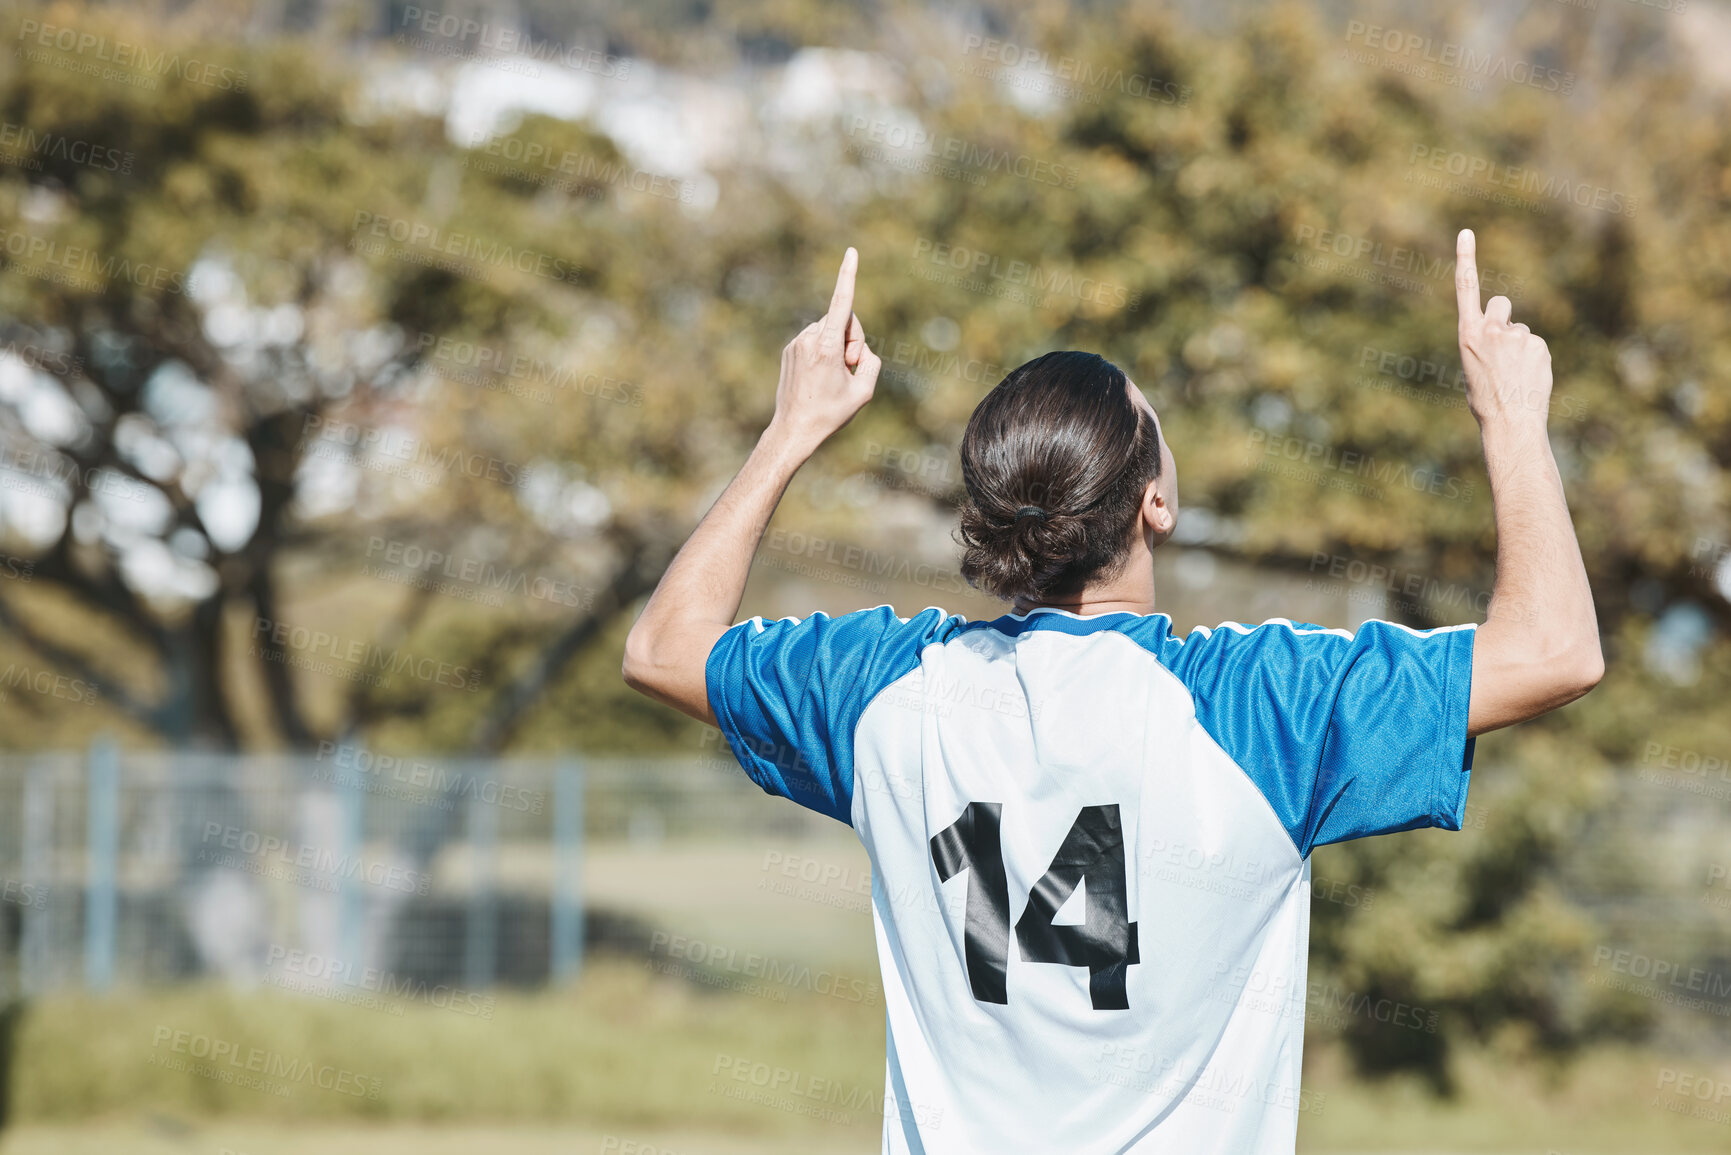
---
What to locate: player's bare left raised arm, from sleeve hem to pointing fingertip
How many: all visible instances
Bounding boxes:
[621,248,883,726]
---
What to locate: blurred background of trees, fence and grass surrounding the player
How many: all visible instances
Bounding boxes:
[0,0,1731,1155]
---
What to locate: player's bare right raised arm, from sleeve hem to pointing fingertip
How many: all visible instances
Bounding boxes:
[1454,229,1605,734]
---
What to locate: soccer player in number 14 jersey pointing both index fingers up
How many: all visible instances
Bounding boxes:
[623,230,1603,1155]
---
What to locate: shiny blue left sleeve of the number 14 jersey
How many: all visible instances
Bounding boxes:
[705,606,950,824]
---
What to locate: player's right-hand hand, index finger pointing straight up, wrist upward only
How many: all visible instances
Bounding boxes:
[1454,229,1551,428]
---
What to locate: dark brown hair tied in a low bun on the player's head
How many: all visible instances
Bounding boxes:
[957,352,1160,601]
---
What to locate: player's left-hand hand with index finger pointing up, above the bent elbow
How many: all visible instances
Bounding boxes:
[770,248,883,454]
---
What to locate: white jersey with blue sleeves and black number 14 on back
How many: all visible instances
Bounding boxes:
[706,606,1473,1155]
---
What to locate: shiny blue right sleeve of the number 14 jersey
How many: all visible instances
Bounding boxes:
[1170,620,1475,855]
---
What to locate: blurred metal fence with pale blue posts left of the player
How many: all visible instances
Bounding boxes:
[0,741,827,994]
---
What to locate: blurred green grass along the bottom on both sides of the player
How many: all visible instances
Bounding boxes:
[0,961,1731,1155]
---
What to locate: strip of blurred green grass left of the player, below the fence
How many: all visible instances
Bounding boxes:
[12,961,883,1134]
